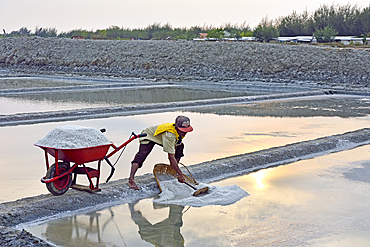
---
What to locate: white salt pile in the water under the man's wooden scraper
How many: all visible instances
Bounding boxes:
[154,180,249,207]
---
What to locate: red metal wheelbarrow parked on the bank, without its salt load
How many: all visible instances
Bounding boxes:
[35,130,146,196]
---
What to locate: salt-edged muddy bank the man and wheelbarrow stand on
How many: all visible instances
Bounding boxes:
[0,128,370,227]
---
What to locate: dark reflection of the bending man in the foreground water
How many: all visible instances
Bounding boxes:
[129,203,184,246]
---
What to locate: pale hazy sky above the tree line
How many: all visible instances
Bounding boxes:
[0,0,370,33]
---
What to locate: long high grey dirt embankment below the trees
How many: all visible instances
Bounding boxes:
[0,37,370,89]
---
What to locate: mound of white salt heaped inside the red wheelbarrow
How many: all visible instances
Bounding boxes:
[35,125,111,149]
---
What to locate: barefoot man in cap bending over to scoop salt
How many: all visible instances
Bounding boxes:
[128,116,193,190]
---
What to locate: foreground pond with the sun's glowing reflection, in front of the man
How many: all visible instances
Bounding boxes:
[26,145,370,247]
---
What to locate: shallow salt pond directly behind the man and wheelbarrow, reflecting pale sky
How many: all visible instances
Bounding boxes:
[0,97,370,202]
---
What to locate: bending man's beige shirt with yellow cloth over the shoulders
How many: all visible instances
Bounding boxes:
[140,123,179,154]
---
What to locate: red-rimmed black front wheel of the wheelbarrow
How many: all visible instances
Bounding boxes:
[45,162,72,196]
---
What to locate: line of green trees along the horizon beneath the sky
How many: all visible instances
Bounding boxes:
[1,4,370,42]
